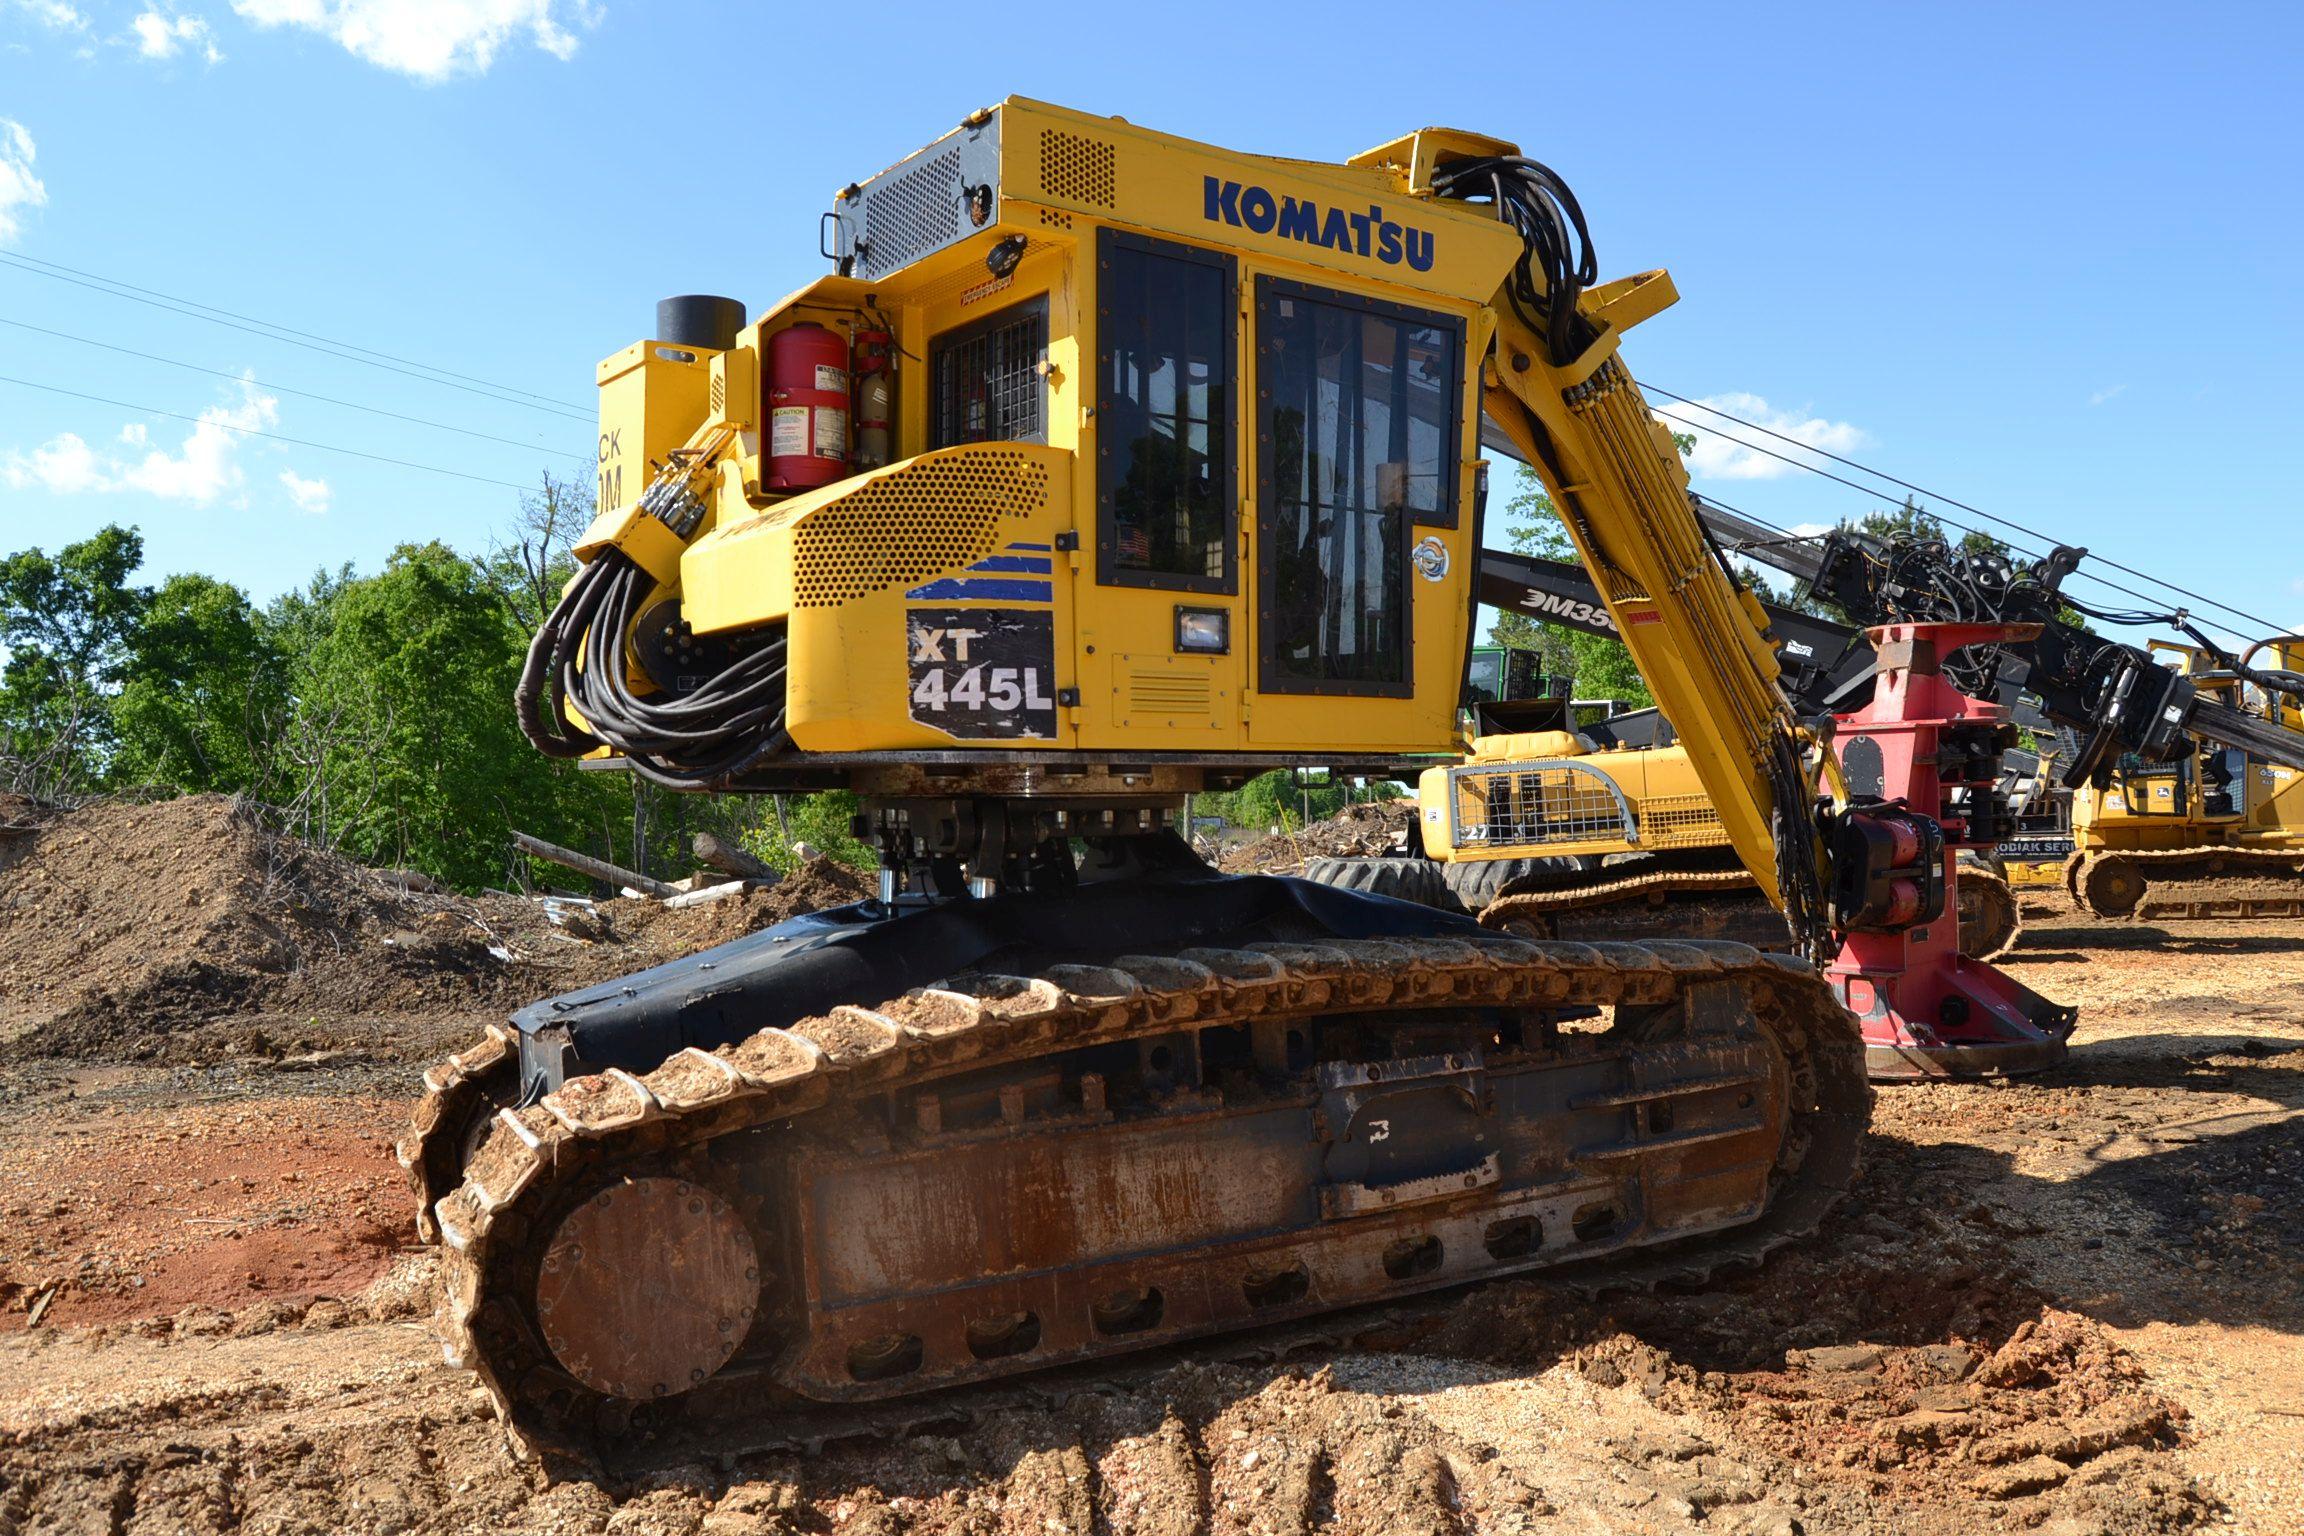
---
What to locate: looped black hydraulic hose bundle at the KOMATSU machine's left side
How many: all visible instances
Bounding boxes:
[514,451,790,790]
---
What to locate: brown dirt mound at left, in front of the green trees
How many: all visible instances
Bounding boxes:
[0,794,866,1059]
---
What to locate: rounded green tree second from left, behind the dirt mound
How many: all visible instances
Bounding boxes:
[111,576,288,792]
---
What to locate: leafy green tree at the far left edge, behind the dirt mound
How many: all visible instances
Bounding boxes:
[0,525,152,794]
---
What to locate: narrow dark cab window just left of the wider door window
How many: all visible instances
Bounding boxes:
[1097,230,1237,592]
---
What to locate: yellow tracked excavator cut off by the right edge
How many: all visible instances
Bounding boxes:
[2064,636,2304,919]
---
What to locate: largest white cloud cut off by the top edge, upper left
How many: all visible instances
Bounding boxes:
[233,0,599,81]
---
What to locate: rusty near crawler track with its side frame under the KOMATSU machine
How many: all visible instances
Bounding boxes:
[412,937,1871,1451]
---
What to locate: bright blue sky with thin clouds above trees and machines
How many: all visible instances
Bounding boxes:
[0,0,2304,626]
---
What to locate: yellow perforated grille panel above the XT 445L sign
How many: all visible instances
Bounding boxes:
[793,451,1048,608]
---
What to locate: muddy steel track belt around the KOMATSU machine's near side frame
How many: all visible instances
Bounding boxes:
[401,937,1871,1458]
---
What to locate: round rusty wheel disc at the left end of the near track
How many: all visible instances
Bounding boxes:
[537,1177,760,1402]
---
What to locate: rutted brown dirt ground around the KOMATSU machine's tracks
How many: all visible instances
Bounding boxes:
[0,810,2304,1536]
